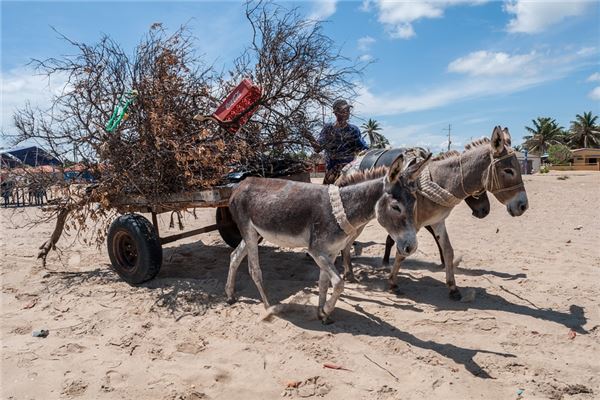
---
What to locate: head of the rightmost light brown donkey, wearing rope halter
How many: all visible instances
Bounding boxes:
[483,126,529,217]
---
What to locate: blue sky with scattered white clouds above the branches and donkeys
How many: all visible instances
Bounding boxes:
[0,0,600,152]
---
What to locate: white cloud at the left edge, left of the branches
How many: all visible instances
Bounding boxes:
[0,68,67,137]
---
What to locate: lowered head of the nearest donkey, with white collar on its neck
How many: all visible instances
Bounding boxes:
[375,153,431,257]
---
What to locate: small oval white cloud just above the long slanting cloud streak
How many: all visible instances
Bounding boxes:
[448,51,538,76]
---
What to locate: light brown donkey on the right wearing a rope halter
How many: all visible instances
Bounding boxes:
[382,126,529,300]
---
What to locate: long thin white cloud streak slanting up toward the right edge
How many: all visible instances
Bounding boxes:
[356,46,598,116]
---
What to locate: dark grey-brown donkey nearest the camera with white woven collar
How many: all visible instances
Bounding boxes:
[225,154,431,323]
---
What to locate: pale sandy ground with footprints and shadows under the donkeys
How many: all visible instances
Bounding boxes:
[0,172,600,400]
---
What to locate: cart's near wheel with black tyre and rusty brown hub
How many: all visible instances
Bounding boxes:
[107,214,162,284]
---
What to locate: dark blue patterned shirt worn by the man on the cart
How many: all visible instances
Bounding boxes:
[318,123,369,169]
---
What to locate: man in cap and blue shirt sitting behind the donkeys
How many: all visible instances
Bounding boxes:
[313,100,369,184]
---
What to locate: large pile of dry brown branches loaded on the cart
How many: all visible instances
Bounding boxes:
[9,2,360,260]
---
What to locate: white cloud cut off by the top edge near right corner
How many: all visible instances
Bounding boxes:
[504,0,594,33]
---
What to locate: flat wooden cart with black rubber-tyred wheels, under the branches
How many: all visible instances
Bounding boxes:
[107,172,310,284]
